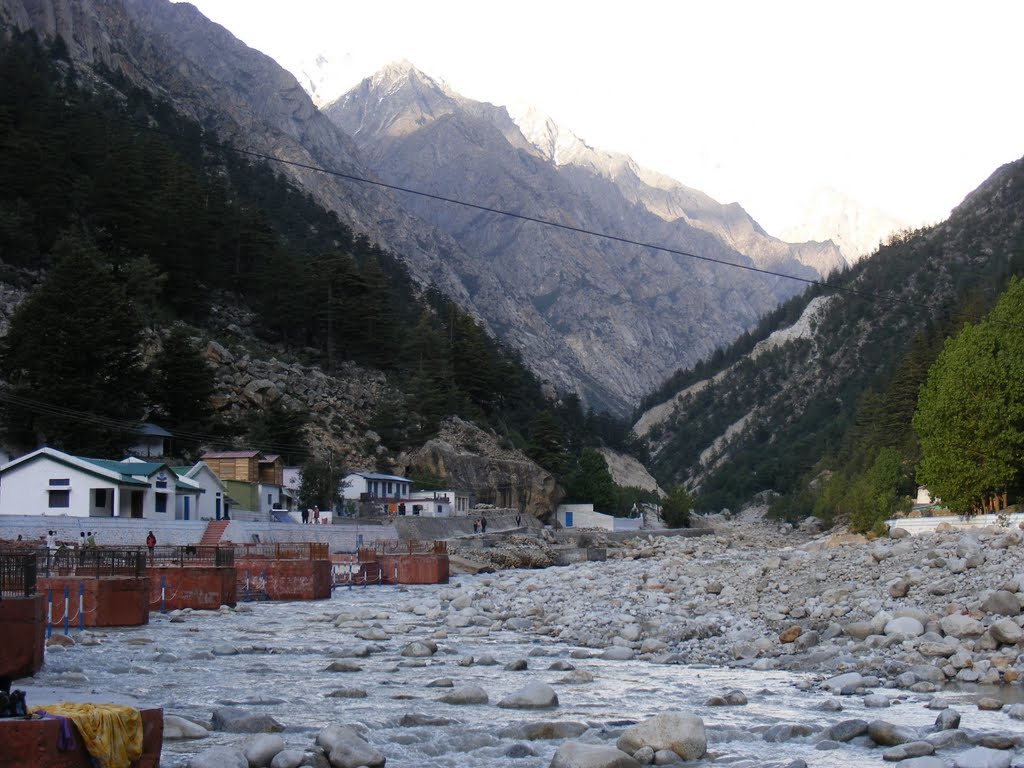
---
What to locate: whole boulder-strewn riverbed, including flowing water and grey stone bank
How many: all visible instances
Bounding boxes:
[18,514,1024,768]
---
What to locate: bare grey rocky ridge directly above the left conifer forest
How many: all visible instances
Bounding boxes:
[0,0,486,315]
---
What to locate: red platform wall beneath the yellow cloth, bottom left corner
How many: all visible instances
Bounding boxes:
[0,701,164,768]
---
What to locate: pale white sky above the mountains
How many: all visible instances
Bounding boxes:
[180,0,1024,233]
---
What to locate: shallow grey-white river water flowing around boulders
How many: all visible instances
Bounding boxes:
[23,577,1019,768]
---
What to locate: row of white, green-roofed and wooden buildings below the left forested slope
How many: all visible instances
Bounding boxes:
[0,425,472,523]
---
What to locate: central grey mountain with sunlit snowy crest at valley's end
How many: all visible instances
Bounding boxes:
[324,62,845,413]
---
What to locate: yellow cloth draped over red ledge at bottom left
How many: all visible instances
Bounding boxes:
[32,701,142,768]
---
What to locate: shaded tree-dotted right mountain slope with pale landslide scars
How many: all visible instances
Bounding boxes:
[634,153,1024,507]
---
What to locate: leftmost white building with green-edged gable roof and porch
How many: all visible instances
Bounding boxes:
[0,447,193,520]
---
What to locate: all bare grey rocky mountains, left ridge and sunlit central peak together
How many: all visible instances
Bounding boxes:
[0,0,840,421]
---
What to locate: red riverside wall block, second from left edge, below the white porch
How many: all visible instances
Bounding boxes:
[36,575,150,627]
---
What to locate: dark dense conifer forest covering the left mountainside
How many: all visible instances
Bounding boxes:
[0,30,647,512]
